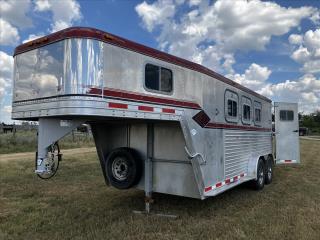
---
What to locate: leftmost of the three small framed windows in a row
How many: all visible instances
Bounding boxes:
[224,90,239,122]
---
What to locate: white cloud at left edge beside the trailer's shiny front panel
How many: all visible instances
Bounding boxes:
[0,51,13,104]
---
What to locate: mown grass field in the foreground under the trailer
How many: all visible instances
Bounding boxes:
[0,140,320,240]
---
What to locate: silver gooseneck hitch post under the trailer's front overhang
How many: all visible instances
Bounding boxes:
[35,118,83,174]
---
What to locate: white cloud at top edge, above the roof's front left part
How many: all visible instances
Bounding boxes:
[35,0,82,32]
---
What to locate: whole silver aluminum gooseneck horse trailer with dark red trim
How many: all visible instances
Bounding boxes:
[12,27,300,211]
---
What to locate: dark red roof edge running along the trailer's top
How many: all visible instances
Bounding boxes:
[14,27,271,102]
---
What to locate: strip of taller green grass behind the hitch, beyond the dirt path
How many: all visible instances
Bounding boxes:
[0,130,94,154]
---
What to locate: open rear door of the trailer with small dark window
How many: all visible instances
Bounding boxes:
[274,102,300,164]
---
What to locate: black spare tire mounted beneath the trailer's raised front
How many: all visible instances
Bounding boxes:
[105,147,142,189]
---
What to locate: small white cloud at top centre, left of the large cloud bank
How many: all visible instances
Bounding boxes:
[135,0,175,32]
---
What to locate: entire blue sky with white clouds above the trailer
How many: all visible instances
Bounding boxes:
[0,0,320,121]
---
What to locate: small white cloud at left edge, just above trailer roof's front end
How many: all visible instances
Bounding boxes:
[0,18,20,45]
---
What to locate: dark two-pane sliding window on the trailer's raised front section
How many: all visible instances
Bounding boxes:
[145,63,172,93]
